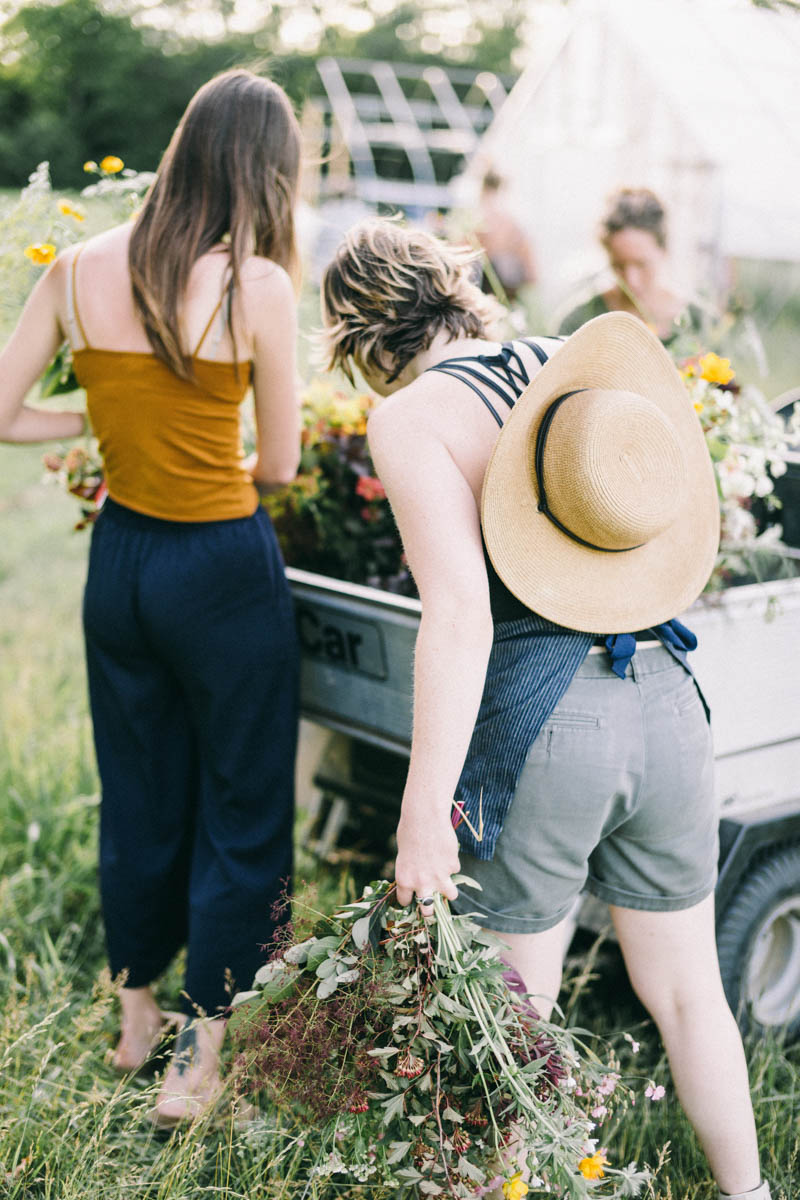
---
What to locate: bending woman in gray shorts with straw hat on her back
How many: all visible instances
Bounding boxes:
[323,222,769,1200]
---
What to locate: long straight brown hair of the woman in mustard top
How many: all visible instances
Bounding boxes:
[128,70,300,378]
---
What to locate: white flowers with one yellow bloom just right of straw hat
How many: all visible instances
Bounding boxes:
[679,354,800,589]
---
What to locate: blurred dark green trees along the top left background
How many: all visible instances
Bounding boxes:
[0,0,527,187]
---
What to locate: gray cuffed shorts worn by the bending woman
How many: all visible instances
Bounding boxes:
[453,647,718,934]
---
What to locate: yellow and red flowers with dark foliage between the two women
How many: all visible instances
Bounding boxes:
[264,379,415,595]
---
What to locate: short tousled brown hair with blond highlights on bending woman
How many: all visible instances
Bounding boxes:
[320,220,499,383]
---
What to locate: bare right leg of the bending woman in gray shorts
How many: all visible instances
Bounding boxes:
[610,895,760,1194]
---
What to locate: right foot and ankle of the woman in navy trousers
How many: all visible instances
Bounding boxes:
[154,1018,225,1126]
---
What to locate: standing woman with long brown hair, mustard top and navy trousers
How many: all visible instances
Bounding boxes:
[0,71,300,1124]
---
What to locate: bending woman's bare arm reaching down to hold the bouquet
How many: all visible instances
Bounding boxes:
[368,396,493,904]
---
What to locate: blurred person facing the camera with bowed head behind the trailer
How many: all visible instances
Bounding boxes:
[559,187,708,347]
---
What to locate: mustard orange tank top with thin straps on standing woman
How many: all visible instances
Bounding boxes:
[67,252,258,521]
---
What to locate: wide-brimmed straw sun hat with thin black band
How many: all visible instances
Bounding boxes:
[481,312,720,634]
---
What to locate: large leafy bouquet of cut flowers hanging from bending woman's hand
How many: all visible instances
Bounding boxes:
[231,876,651,1200]
